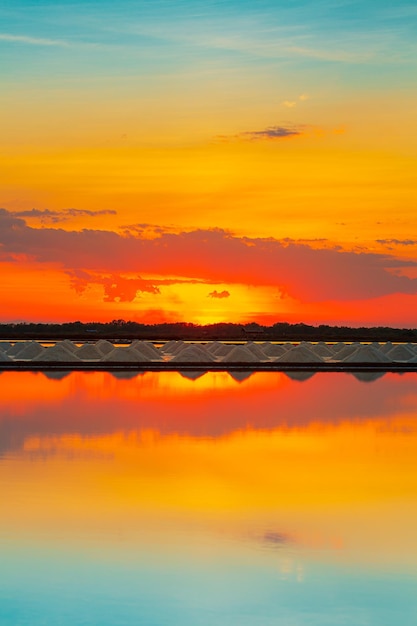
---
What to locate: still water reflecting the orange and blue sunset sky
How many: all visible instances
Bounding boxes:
[0,372,417,626]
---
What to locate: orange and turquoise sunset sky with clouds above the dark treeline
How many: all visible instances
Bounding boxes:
[0,0,417,328]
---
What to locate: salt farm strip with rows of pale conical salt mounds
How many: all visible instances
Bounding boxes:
[0,339,417,371]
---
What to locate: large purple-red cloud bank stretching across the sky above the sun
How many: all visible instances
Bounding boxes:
[0,209,417,302]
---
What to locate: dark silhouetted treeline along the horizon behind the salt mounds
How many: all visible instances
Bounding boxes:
[0,319,417,342]
